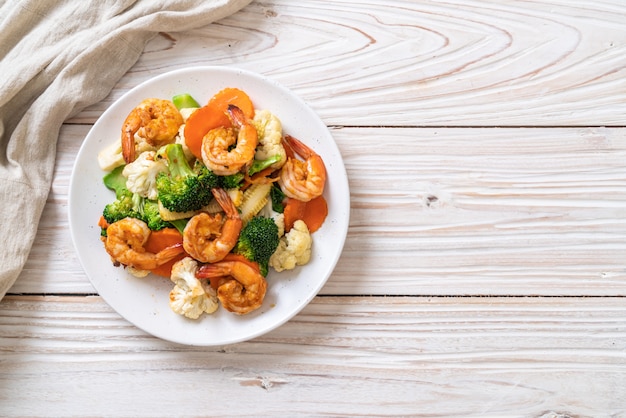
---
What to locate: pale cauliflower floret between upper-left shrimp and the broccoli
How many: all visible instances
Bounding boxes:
[122,151,167,200]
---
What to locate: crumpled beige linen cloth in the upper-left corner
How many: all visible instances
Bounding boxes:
[0,0,250,298]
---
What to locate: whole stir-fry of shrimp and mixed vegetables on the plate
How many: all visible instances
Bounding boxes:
[98,88,328,319]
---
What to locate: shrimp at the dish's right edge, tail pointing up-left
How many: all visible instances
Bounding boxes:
[278,135,326,202]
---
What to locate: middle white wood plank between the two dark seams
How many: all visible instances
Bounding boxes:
[11,125,626,296]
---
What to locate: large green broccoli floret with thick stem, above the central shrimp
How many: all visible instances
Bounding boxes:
[156,144,220,212]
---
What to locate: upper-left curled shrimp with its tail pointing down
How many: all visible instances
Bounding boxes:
[122,99,183,164]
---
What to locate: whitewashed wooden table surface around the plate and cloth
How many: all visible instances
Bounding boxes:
[0,0,626,417]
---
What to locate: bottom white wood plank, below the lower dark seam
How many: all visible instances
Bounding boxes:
[0,297,626,417]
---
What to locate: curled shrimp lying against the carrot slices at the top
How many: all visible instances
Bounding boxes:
[202,105,259,176]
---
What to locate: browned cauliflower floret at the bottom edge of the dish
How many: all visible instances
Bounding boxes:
[170,257,218,319]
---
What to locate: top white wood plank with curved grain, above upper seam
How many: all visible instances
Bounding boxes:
[68,0,626,126]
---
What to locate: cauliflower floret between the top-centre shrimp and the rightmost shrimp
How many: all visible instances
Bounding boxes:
[252,110,287,169]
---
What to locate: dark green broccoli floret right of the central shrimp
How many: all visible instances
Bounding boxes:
[233,216,280,276]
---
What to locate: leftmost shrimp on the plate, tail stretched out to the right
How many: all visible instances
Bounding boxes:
[104,218,184,270]
